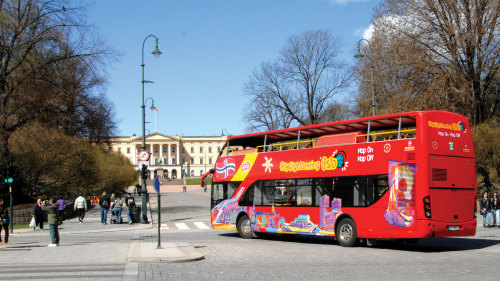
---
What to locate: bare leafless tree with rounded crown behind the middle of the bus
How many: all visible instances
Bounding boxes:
[244,30,351,130]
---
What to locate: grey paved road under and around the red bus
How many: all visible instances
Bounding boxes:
[0,186,500,281]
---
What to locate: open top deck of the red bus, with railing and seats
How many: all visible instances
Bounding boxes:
[219,112,419,156]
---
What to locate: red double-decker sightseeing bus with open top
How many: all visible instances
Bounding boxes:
[206,111,476,246]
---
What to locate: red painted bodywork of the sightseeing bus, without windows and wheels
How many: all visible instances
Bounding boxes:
[212,112,476,238]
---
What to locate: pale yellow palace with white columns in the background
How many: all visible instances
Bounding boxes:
[110,133,227,178]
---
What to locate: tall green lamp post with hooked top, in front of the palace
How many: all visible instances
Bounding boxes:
[141,35,161,223]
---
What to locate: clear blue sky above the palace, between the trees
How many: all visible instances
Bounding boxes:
[88,0,379,136]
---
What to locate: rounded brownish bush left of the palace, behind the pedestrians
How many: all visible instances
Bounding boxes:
[9,123,135,198]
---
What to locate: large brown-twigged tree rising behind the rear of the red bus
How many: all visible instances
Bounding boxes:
[360,0,500,124]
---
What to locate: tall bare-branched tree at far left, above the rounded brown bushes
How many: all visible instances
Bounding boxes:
[0,0,114,165]
